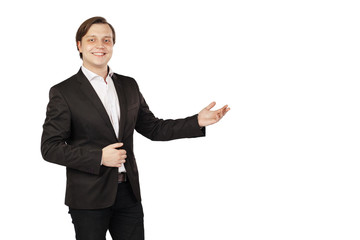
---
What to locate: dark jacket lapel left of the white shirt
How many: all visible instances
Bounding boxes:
[77,69,116,139]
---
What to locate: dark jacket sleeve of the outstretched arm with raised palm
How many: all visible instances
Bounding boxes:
[135,93,205,141]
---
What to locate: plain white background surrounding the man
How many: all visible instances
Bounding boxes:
[0,0,360,240]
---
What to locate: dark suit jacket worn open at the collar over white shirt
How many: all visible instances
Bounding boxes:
[41,69,205,209]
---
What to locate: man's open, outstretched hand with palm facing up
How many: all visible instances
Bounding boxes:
[198,102,230,127]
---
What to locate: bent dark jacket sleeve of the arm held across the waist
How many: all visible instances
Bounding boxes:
[41,87,102,174]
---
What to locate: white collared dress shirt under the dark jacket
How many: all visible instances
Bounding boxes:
[81,66,126,172]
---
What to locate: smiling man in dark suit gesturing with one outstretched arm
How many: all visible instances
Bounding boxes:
[41,17,230,240]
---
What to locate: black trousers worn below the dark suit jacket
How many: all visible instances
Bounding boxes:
[69,182,144,240]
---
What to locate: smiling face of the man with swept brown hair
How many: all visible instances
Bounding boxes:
[77,23,114,70]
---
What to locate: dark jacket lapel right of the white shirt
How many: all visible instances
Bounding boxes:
[111,74,127,141]
